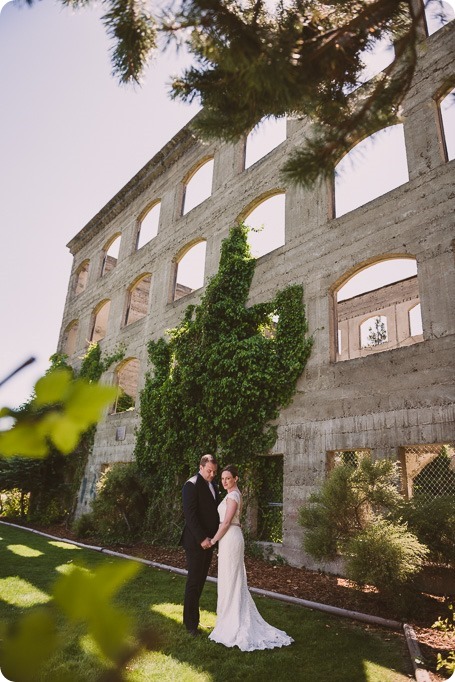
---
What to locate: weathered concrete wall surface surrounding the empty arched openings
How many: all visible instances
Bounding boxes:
[62,22,455,568]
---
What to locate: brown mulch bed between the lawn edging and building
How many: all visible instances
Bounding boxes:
[5,524,455,682]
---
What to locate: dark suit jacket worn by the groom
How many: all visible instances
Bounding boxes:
[180,474,220,550]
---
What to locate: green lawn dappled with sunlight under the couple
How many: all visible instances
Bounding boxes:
[0,525,412,682]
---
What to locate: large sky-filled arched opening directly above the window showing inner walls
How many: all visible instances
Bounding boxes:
[335,123,409,217]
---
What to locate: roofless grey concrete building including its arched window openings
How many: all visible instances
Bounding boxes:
[59,21,455,567]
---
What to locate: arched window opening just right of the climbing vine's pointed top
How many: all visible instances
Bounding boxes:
[243,192,286,258]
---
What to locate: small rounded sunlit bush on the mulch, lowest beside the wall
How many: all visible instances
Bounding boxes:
[346,517,428,592]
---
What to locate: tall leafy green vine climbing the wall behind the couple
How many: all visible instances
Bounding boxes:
[134,224,312,541]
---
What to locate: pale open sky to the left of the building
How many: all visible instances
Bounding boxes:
[0,0,454,407]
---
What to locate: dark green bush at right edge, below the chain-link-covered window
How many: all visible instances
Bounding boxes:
[399,495,455,565]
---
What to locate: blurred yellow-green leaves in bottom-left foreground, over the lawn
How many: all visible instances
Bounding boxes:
[0,561,144,682]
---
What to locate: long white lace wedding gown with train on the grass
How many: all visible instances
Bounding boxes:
[209,490,294,651]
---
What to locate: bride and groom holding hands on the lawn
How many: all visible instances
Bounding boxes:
[180,455,293,651]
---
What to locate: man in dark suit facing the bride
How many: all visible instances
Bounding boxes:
[180,455,220,637]
